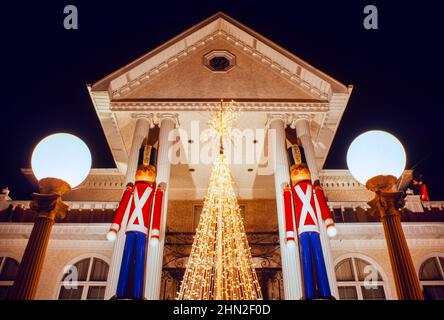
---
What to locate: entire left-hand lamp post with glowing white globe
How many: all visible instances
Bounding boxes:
[9,133,91,300]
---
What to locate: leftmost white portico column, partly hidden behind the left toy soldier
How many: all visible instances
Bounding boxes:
[105,115,152,299]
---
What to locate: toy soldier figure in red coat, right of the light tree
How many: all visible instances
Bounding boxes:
[284,145,336,300]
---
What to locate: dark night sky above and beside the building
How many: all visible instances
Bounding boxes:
[0,0,444,200]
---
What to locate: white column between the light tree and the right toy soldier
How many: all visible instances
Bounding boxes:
[268,114,302,300]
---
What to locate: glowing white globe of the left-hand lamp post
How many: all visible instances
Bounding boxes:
[31,133,91,189]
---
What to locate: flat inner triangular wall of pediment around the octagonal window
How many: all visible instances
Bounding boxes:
[116,37,319,101]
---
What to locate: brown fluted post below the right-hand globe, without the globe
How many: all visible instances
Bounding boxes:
[369,191,424,300]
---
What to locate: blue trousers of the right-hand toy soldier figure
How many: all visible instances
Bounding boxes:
[299,232,332,300]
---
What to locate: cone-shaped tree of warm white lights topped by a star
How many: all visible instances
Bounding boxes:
[177,100,262,300]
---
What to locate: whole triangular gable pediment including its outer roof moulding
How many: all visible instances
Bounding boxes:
[92,13,347,101]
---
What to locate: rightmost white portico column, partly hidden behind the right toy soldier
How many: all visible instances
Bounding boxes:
[291,115,339,298]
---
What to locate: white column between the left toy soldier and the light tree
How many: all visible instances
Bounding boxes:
[145,114,177,300]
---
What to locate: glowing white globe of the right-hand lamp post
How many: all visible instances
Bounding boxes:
[347,130,406,191]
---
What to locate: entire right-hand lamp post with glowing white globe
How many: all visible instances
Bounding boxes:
[347,130,424,300]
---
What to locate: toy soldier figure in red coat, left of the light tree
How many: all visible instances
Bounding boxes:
[107,145,164,299]
